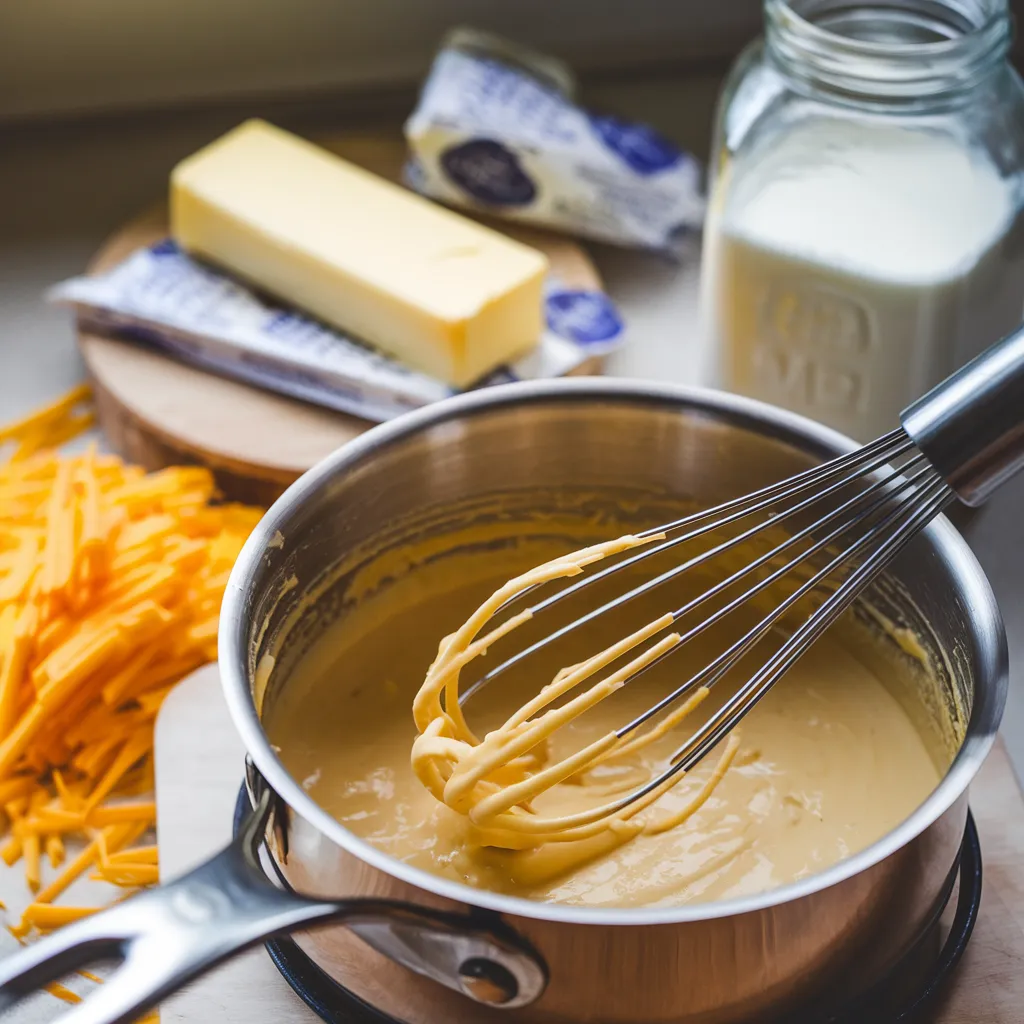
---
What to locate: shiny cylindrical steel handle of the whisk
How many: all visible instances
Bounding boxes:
[900,327,1024,506]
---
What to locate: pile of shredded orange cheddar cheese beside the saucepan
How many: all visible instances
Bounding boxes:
[0,387,261,970]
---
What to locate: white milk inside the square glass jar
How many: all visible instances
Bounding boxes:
[703,120,1024,441]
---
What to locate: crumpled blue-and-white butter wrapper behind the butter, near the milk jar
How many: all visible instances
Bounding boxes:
[406,30,705,252]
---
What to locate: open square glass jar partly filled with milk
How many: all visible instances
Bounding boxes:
[701,0,1024,441]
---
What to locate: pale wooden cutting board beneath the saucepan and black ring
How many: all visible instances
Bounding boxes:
[151,666,1024,1024]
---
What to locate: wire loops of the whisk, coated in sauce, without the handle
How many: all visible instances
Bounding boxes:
[413,431,953,849]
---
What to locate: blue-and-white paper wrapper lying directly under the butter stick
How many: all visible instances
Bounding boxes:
[47,241,623,423]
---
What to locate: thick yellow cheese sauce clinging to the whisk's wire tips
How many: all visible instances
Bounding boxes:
[412,535,739,857]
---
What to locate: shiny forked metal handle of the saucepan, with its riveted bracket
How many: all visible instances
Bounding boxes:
[0,787,547,1024]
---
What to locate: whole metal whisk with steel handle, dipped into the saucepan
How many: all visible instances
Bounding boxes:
[414,329,1024,839]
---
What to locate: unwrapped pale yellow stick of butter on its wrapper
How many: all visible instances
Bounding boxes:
[171,120,548,387]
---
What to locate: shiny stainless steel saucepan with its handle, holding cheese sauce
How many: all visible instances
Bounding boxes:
[0,379,1007,1024]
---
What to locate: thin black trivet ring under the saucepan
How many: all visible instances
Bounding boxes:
[234,787,981,1024]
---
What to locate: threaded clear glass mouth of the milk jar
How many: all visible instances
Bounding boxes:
[765,0,1011,105]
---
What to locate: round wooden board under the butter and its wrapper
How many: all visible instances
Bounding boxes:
[78,136,601,505]
